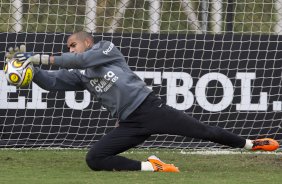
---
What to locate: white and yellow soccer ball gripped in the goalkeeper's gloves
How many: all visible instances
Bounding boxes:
[4,58,33,87]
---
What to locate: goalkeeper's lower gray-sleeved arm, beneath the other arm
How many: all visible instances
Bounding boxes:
[33,67,85,91]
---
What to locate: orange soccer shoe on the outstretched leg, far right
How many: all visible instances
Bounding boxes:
[252,138,279,151]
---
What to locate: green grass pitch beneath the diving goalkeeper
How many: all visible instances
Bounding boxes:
[0,149,282,184]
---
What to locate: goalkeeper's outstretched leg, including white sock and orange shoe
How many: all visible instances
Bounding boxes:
[155,108,279,151]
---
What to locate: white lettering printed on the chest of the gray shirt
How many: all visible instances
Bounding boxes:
[90,71,118,93]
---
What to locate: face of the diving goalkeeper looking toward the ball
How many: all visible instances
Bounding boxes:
[67,36,89,53]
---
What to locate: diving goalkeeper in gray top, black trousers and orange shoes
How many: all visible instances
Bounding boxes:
[7,32,279,172]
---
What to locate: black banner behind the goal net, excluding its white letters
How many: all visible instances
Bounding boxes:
[0,33,282,148]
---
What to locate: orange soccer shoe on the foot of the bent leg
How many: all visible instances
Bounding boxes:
[148,155,179,172]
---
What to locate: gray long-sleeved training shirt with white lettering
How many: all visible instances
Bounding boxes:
[33,41,152,120]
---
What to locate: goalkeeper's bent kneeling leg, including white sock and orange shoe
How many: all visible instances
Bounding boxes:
[86,122,179,172]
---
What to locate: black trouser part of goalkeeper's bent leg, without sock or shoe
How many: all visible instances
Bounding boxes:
[86,125,150,171]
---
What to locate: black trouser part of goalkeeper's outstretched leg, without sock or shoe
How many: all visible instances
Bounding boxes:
[150,105,246,148]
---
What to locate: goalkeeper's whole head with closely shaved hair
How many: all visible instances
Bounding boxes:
[67,31,94,53]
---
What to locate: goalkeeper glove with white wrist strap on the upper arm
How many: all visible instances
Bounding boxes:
[14,52,50,65]
